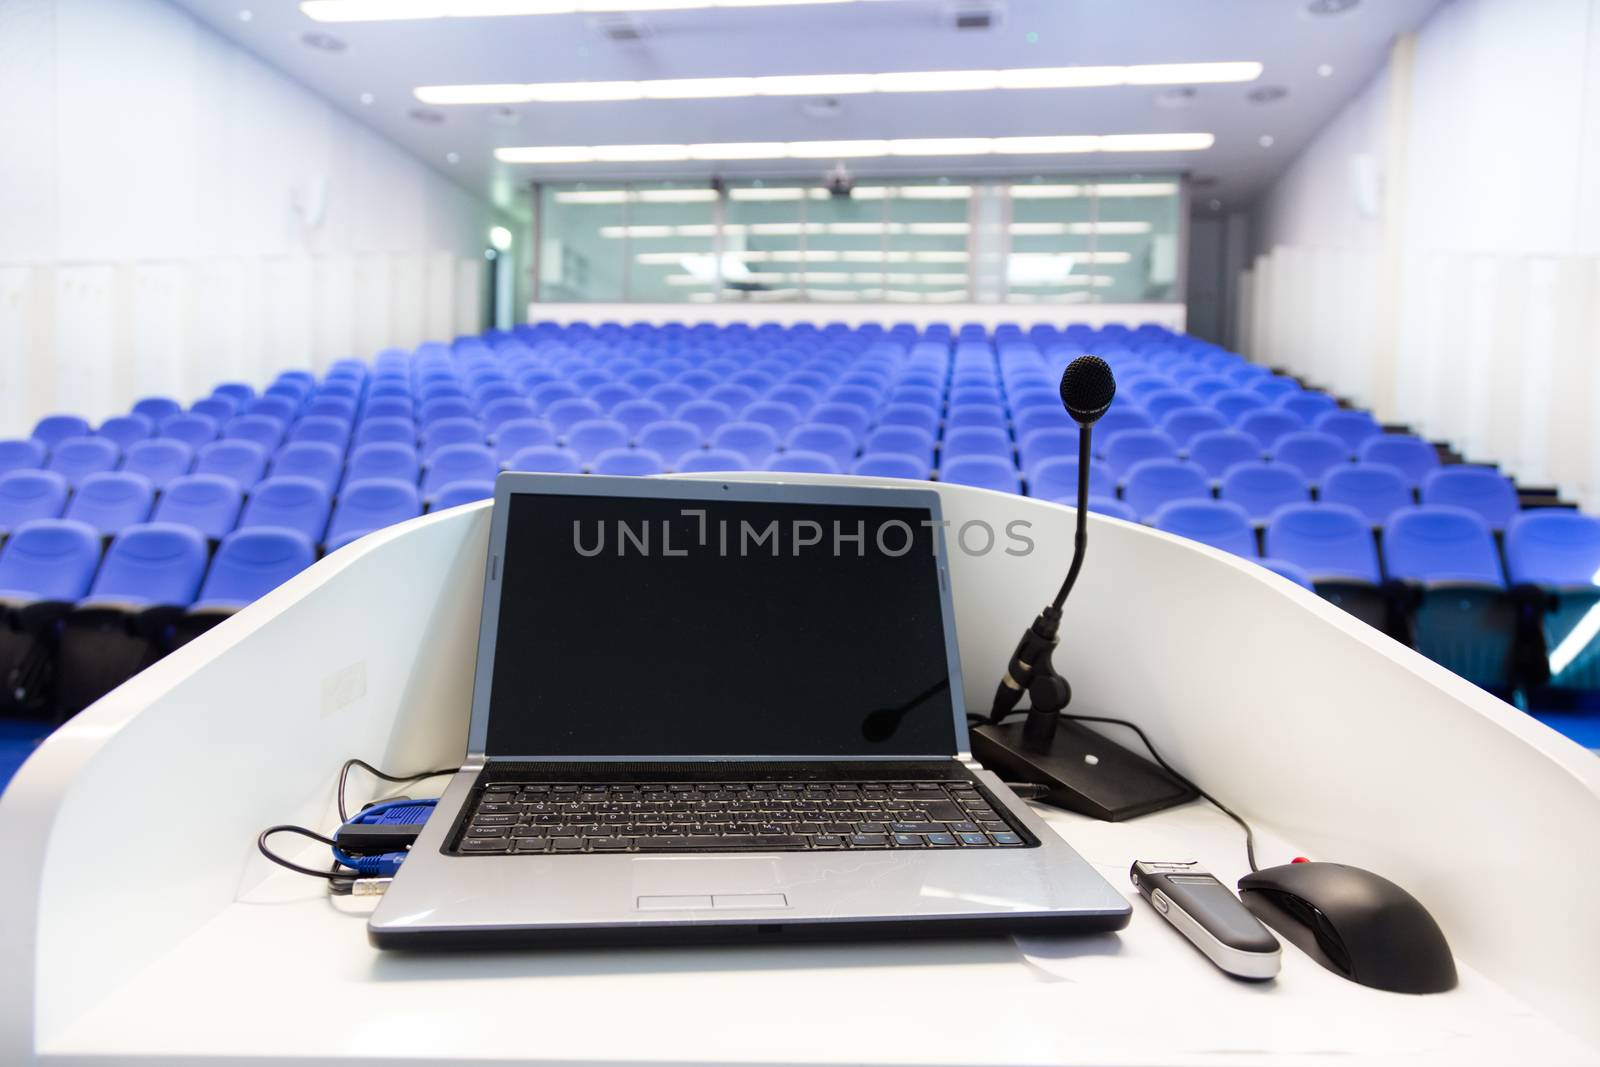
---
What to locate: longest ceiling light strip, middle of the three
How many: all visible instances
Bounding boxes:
[413,62,1261,107]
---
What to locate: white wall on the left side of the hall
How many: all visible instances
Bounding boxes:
[0,0,493,437]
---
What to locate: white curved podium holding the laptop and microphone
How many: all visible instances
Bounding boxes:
[0,475,1600,1065]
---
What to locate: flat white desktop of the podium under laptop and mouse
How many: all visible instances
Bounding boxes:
[40,803,1600,1065]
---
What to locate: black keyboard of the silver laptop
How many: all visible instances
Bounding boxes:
[451,781,1035,856]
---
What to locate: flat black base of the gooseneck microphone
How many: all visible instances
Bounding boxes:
[971,718,1198,822]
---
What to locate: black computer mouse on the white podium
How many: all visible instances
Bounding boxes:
[1238,862,1456,993]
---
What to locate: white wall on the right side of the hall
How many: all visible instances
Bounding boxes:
[1242,0,1600,509]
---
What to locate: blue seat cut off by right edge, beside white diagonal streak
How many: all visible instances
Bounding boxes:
[1504,507,1600,707]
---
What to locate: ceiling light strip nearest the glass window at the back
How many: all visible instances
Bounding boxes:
[494,133,1216,165]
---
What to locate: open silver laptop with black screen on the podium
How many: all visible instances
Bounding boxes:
[368,474,1130,949]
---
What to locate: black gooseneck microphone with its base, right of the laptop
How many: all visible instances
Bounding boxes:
[971,355,1195,821]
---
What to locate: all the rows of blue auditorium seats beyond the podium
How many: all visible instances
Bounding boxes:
[0,316,1600,712]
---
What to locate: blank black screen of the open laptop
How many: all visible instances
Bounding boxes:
[486,494,957,757]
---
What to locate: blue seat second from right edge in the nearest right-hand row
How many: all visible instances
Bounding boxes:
[1384,504,1520,696]
